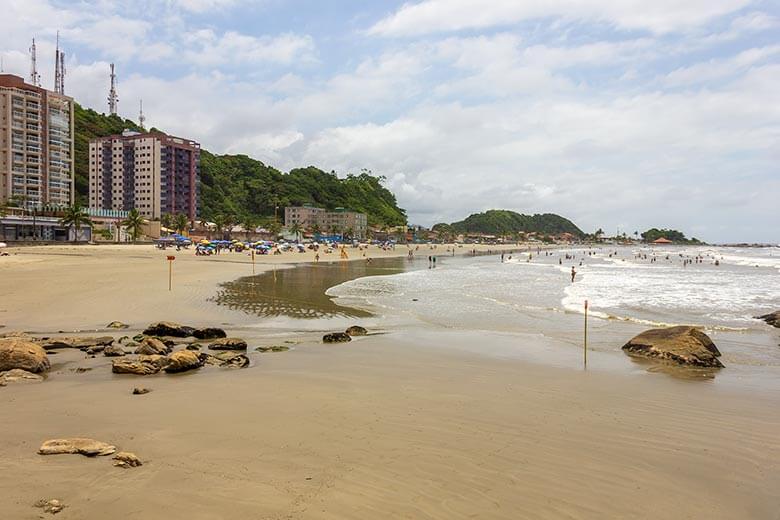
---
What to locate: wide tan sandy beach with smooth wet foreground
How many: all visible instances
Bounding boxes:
[0,246,780,519]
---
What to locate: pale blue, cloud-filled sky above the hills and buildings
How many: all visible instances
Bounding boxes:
[0,0,780,243]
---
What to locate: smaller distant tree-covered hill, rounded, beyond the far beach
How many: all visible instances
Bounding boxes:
[450,209,585,237]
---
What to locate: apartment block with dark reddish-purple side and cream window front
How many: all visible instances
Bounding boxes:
[89,130,200,220]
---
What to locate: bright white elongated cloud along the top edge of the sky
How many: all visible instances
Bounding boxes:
[368,0,750,36]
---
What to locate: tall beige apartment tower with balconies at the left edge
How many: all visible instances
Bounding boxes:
[0,74,74,207]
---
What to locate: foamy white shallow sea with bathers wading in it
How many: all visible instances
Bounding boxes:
[327,246,780,373]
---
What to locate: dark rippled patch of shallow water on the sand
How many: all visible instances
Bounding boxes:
[214,258,410,319]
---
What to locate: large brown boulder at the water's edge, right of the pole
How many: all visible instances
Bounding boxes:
[623,325,723,368]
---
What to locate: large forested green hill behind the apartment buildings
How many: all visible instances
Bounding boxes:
[74,104,406,226]
